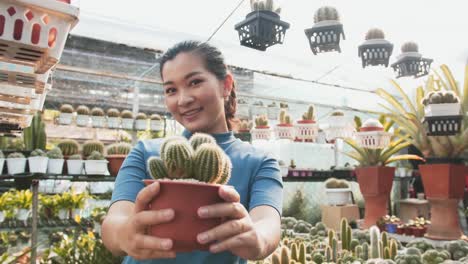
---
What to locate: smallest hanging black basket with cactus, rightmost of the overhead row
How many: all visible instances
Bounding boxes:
[392,42,433,78]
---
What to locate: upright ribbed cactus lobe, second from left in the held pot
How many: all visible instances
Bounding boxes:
[163,140,193,178]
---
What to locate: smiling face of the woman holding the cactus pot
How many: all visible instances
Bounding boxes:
[162,52,232,134]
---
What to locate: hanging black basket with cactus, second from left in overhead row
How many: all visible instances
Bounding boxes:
[304,6,345,55]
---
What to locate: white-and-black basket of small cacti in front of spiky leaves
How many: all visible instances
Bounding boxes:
[422,91,463,136]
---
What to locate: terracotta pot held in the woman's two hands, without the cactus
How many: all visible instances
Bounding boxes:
[144,180,223,252]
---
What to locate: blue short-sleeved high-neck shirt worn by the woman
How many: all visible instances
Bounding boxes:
[111,130,283,264]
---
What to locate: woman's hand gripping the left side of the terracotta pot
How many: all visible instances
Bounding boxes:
[119,182,176,260]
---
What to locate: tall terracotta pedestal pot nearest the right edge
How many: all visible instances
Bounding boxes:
[419,163,465,240]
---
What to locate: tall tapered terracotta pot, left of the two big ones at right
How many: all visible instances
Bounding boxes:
[356,166,395,229]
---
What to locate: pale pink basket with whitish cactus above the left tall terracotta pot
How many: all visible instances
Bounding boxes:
[356,118,392,149]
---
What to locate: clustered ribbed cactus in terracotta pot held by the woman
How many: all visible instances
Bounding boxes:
[145,133,232,252]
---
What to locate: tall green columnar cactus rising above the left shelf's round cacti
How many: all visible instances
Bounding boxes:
[23,112,47,150]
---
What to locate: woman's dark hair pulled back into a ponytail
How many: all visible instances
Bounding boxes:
[159,40,237,130]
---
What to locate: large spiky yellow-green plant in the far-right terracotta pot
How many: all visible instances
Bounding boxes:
[376,65,468,158]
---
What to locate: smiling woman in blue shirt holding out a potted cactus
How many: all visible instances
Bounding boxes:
[102,41,283,264]
